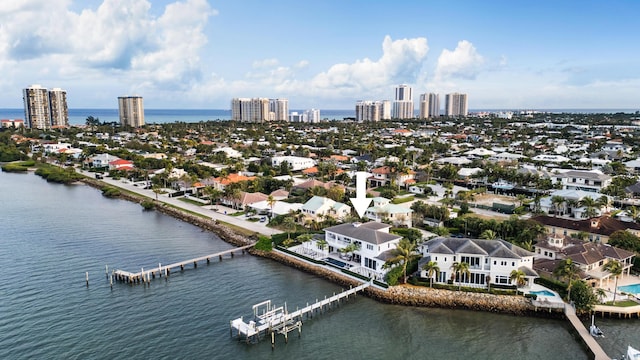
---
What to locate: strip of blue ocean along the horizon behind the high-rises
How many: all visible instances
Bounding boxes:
[0,108,638,125]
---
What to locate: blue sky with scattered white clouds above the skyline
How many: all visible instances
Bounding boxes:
[0,0,640,110]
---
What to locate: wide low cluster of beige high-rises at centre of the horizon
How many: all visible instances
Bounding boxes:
[231,98,289,123]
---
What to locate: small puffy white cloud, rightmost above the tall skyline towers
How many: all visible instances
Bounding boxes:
[435,40,484,82]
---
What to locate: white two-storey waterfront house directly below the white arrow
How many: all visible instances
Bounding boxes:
[324,221,402,278]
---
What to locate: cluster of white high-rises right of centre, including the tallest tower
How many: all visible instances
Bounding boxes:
[356,84,469,121]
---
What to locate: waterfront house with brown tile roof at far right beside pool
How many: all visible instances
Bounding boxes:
[533,234,635,287]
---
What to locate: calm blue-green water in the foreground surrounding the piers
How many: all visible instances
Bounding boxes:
[0,173,640,359]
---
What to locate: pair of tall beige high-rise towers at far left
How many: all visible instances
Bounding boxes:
[22,85,69,130]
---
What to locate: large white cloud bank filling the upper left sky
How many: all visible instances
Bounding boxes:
[0,0,216,101]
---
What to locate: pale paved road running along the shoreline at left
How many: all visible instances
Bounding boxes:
[76,168,282,236]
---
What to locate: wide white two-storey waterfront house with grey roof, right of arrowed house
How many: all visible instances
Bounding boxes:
[418,237,538,287]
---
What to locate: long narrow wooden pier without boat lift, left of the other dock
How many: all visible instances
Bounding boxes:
[111,244,255,284]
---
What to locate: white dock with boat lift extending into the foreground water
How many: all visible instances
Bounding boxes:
[229,282,372,348]
